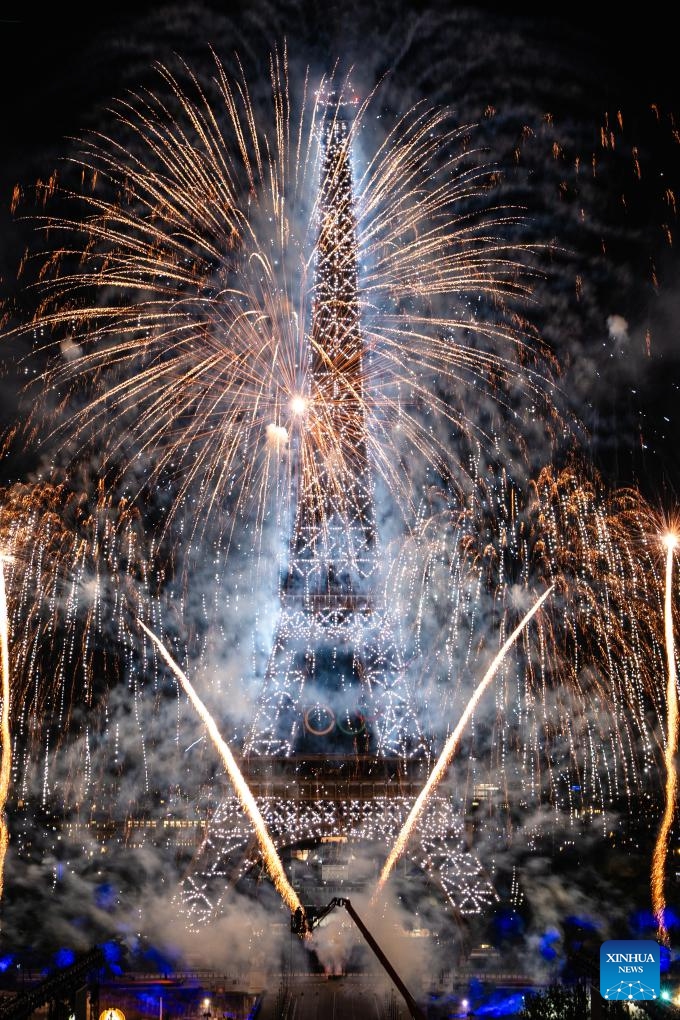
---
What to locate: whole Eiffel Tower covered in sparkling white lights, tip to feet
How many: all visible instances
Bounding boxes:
[182,87,495,929]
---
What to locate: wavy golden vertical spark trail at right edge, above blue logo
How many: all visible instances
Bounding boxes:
[651,534,678,946]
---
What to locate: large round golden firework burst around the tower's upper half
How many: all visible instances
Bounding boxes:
[11,54,557,550]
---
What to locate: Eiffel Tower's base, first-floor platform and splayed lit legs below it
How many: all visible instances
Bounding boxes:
[182,756,498,927]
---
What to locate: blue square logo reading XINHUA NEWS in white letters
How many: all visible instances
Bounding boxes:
[599,938,661,1003]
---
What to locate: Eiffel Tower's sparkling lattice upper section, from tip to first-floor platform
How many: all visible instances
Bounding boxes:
[245,91,424,758]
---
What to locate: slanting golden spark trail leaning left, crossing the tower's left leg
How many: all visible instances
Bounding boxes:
[138,620,302,913]
